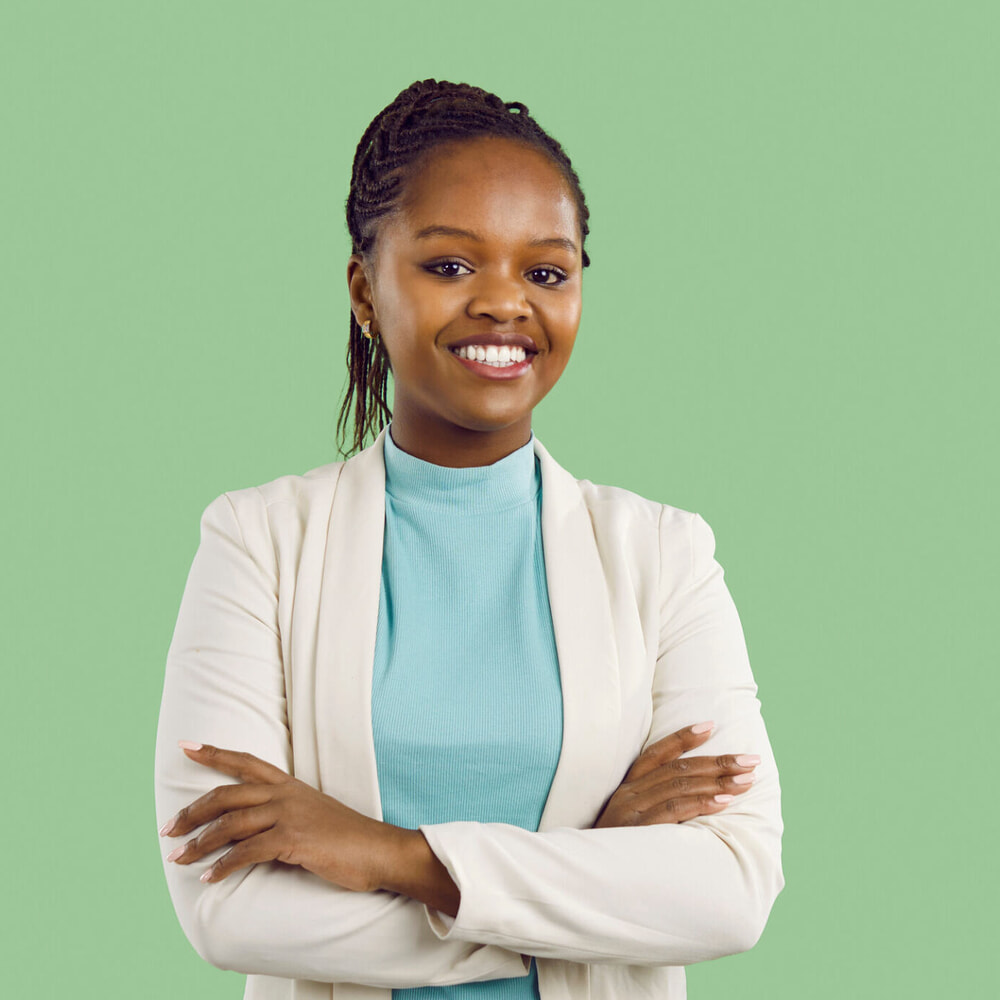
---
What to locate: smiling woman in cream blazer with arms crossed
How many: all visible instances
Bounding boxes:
[156,80,783,1000]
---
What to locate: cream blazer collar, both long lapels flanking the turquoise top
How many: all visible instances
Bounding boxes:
[314,429,621,830]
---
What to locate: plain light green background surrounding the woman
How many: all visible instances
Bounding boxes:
[0,0,1000,1000]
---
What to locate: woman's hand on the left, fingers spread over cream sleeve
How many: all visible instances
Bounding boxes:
[160,744,410,892]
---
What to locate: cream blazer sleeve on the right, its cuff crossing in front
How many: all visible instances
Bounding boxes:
[421,508,784,965]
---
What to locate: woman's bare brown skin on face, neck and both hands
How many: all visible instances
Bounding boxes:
[160,138,759,916]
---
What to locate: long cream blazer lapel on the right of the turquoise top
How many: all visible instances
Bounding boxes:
[535,438,621,830]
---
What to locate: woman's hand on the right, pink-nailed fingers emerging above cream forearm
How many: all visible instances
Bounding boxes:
[594,722,760,829]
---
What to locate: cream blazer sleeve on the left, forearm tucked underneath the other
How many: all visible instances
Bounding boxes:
[155,495,526,988]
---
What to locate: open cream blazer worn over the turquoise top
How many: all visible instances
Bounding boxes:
[156,430,784,1000]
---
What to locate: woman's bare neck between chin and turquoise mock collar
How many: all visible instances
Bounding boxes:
[391,409,531,469]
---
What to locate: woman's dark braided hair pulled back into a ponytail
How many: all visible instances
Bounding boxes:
[337,80,590,457]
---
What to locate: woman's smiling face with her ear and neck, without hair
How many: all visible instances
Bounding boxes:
[348,137,582,466]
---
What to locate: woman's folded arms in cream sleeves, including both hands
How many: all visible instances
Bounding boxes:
[157,496,780,987]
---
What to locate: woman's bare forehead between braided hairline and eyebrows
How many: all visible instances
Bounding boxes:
[397,136,579,240]
